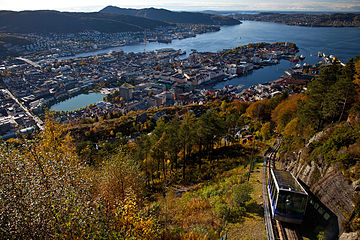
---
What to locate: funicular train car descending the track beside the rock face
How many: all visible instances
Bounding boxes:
[267,169,308,224]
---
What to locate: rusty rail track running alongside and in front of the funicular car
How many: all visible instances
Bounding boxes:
[262,139,302,240]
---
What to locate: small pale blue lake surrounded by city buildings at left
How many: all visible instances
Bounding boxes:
[51,93,105,111]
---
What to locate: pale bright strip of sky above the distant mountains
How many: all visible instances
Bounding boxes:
[0,0,360,12]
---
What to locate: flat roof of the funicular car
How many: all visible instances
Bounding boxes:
[272,169,307,194]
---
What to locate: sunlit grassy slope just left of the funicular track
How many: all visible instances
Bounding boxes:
[157,149,266,239]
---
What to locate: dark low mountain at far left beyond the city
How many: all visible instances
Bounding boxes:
[0,11,169,33]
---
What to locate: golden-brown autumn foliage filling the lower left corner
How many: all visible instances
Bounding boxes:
[0,115,157,239]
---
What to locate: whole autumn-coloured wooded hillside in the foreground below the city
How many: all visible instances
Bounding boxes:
[0,56,360,240]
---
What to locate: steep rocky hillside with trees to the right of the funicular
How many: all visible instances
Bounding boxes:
[272,56,360,234]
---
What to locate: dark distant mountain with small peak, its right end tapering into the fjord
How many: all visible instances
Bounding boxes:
[100,6,240,25]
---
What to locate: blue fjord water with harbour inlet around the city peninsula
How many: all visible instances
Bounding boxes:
[54,21,360,110]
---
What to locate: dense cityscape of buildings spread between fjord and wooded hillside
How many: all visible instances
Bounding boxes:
[1,39,317,138]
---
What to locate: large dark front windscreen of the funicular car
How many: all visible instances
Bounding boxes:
[277,191,307,215]
